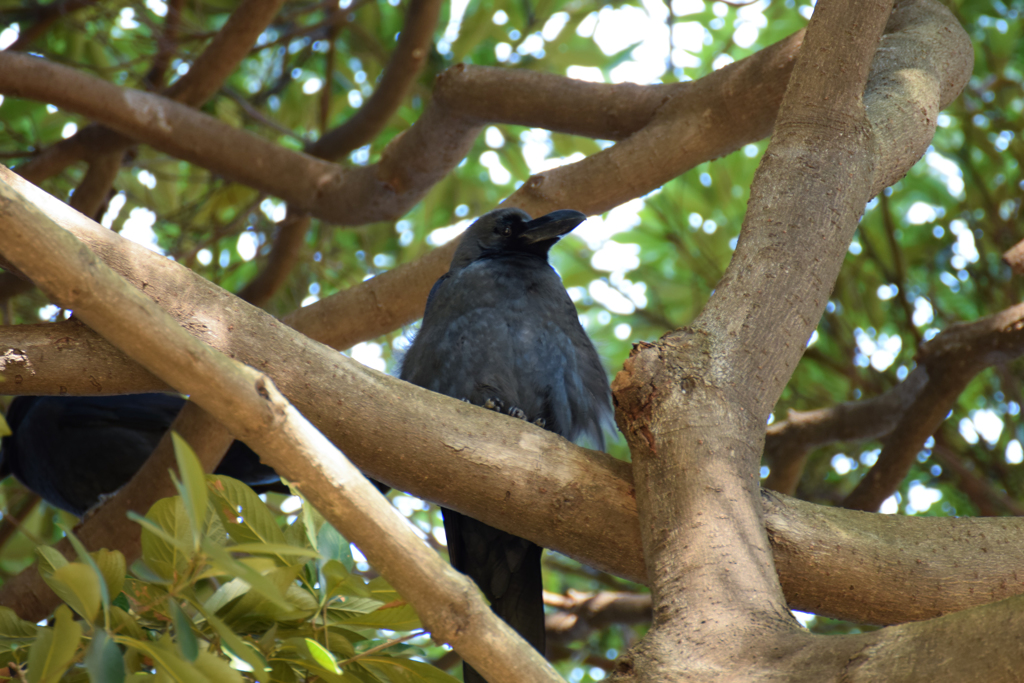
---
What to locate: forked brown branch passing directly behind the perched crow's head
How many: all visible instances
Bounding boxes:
[285,33,803,348]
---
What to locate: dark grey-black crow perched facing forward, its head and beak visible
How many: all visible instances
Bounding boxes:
[400,209,613,683]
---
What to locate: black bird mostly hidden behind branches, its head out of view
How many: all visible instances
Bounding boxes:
[0,393,281,516]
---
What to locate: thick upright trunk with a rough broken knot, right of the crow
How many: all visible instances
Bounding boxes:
[612,2,889,681]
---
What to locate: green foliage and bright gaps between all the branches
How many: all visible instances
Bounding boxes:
[0,0,1024,683]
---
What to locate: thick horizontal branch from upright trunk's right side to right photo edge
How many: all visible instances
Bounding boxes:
[762,492,1024,625]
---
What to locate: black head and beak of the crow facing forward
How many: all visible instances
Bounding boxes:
[452,209,587,270]
